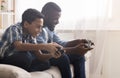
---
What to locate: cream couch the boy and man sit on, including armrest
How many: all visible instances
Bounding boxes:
[0,64,73,78]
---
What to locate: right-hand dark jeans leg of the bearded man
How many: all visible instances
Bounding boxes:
[68,54,86,78]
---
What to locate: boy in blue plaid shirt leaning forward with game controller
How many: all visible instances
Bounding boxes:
[0,9,61,71]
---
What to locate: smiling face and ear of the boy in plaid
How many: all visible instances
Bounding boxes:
[24,18,43,37]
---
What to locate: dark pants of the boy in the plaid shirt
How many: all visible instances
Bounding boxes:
[2,52,50,72]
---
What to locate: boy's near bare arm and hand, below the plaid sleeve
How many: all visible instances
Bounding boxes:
[13,41,59,53]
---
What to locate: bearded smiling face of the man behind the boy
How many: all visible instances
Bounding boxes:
[45,11,61,31]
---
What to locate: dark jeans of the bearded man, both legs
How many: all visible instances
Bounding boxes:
[50,54,86,78]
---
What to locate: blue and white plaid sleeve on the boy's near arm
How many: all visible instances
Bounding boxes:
[0,26,22,57]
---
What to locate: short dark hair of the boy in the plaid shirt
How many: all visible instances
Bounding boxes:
[22,8,44,25]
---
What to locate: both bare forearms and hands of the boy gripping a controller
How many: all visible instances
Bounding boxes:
[14,41,61,61]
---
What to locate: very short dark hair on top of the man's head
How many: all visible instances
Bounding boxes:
[41,2,61,15]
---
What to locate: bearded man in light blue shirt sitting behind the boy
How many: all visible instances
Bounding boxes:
[37,2,92,78]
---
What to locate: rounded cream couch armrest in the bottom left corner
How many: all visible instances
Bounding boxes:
[0,64,31,78]
